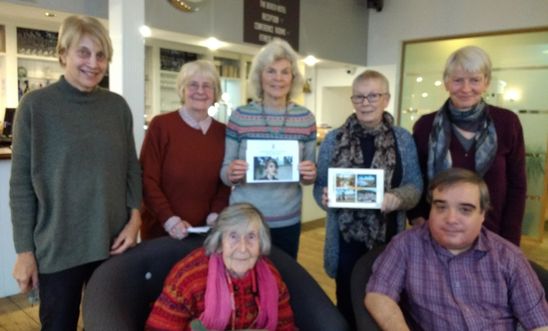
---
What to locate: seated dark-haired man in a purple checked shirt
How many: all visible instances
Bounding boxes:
[365,168,548,330]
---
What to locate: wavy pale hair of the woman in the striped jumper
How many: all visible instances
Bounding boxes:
[249,38,304,100]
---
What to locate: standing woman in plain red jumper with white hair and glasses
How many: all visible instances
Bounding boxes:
[141,60,230,239]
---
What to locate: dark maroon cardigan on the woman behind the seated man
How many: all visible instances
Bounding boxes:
[407,105,527,246]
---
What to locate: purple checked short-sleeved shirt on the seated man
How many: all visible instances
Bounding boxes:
[366,223,548,330]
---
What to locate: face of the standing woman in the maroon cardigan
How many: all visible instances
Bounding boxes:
[445,69,489,110]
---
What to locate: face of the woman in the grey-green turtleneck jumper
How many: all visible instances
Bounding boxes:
[60,35,108,92]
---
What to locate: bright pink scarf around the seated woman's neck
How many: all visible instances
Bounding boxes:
[200,253,279,331]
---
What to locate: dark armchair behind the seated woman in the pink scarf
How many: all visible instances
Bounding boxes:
[83,236,348,331]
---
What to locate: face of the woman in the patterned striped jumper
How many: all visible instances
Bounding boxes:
[261,59,293,101]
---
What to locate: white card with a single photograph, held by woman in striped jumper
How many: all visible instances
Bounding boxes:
[246,140,299,183]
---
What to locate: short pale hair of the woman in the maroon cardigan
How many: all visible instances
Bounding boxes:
[443,46,491,83]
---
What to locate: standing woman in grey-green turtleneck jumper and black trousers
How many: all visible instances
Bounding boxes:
[10,16,141,330]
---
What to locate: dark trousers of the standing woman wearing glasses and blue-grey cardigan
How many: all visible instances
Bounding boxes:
[335,233,369,330]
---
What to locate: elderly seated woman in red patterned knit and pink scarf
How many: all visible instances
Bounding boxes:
[146,203,296,331]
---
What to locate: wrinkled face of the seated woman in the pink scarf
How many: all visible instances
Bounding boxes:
[222,222,260,277]
